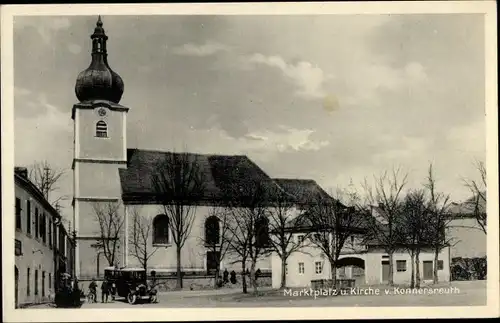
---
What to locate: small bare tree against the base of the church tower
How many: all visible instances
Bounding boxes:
[93,202,125,266]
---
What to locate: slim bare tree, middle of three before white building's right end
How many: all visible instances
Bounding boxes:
[397,190,429,288]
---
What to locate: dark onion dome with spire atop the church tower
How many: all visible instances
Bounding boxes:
[75,16,124,103]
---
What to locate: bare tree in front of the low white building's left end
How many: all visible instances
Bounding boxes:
[269,186,310,288]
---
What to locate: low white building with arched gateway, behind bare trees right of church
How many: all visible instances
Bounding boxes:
[271,233,451,288]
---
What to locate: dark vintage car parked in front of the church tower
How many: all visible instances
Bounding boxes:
[104,267,157,304]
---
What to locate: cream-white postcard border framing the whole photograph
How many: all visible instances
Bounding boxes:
[1,1,499,322]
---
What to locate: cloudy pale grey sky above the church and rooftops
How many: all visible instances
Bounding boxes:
[14,14,486,221]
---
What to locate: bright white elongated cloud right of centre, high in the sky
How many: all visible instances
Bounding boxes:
[248,53,331,99]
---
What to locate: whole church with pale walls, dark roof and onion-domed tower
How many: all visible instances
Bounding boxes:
[72,17,326,280]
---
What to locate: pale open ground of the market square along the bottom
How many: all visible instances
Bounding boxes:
[82,281,486,308]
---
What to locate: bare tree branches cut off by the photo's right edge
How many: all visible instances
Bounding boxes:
[464,161,487,234]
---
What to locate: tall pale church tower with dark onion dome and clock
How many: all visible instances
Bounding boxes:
[71,16,129,279]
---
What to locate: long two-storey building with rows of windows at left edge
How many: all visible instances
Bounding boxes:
[14,167,73,306]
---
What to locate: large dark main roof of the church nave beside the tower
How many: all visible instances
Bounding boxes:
[119,149,290,204]
